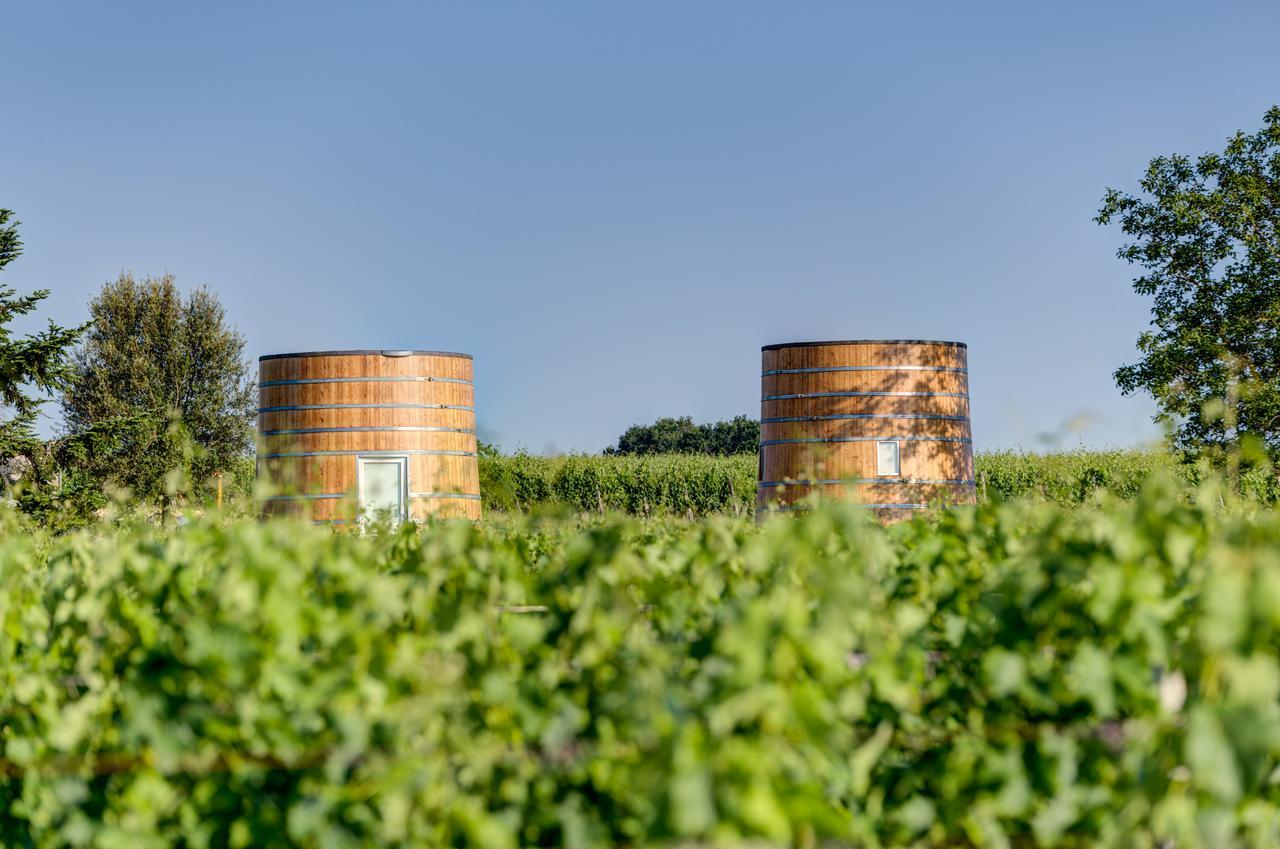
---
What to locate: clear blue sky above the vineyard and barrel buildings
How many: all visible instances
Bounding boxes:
[0,0,1280,452]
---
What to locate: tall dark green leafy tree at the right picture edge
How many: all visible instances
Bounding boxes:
[1096,106,1280,452]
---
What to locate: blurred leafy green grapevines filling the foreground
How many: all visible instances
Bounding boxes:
[0,473,1280,849]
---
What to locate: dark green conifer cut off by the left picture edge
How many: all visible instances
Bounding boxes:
[0,209,86,501]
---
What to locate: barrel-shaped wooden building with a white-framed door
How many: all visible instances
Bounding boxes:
[257,351,480,524]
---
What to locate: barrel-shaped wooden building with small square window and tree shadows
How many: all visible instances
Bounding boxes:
[756,339,975,520]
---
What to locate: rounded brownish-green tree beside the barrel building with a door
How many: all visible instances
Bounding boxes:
[63,274,255,502]
